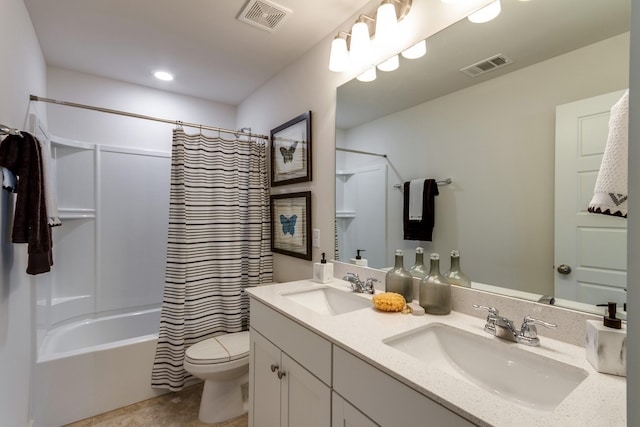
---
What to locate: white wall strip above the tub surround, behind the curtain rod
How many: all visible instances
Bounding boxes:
[47,67,236,152]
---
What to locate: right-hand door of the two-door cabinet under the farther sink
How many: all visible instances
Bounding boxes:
[282,353,331,427]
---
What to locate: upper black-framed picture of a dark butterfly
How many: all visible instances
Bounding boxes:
[270,111,311,187]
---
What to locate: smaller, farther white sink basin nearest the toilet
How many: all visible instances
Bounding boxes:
[282,286,373,316]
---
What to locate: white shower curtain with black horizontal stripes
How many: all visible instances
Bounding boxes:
[151,129,273,391]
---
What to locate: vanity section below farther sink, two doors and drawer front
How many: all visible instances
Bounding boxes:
[249,300,331,427]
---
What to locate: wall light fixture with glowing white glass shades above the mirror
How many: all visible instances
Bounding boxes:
[329,0,412,81]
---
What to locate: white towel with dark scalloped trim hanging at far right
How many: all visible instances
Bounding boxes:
[588,90,629,218]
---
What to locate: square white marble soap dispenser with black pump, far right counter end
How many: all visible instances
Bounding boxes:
[586,302,627,377]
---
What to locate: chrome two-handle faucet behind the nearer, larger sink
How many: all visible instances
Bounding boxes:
[473,304,558,347]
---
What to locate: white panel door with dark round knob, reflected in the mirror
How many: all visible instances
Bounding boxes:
[554,91,627,304]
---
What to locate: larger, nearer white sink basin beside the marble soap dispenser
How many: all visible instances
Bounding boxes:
[383,323,588,411]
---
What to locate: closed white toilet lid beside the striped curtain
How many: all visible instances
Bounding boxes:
[185,331,249,364]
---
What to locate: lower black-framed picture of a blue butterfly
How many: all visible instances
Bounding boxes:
[271,191,311,261]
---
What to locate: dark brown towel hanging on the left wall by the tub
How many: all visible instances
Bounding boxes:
[0,132,53,274]
